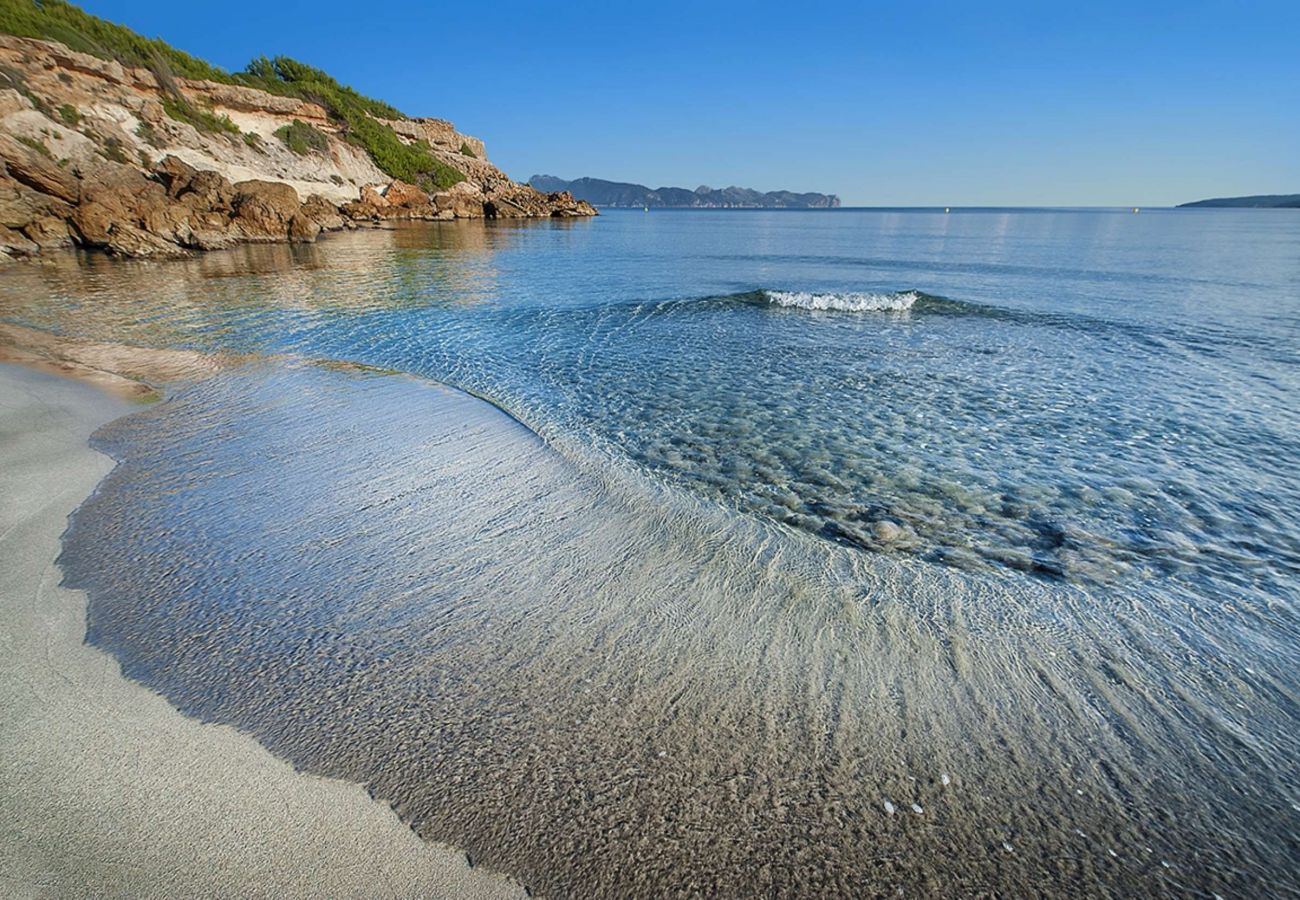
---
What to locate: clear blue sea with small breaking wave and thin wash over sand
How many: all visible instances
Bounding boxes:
[0,211,1300,896]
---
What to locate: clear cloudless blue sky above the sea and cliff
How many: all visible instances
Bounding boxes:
[83,0,1300,205]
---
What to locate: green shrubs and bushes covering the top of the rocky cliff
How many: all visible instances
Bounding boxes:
[0,0,464,190]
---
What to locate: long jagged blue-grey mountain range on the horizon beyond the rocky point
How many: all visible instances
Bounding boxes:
[528,176,840,209]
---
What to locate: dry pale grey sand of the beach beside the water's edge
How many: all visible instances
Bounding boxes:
[0,364,525,897]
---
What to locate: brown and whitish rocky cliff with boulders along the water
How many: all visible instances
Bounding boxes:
[0,29,595,261]
